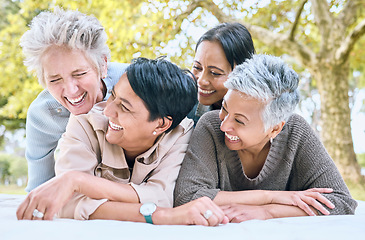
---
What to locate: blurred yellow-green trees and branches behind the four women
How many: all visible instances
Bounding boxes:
[0,0,365,191]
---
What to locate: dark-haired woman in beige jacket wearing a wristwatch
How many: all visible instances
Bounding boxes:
[17,58,227,225]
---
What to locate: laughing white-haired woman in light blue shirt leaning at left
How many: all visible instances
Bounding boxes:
[20,8,128,192]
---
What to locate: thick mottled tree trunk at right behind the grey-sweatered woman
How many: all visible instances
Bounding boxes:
[314,59,363,182]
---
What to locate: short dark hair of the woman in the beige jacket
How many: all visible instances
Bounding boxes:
[126,57,198,132]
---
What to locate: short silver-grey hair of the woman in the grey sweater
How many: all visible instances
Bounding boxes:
[224,54,299,131]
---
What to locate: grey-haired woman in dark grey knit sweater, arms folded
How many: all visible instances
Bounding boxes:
[175,55,357,222]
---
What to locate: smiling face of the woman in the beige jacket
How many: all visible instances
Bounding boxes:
[104,73,161,156]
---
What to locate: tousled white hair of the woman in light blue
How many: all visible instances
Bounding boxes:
[20,7,110,87]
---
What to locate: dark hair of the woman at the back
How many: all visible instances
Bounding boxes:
[195,22,255,70]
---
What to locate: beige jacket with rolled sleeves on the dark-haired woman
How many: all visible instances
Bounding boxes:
[55,102,193,219]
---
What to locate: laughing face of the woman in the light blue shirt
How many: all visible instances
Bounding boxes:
[42,46,104,115]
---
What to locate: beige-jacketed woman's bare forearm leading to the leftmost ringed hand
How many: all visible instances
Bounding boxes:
[69,171,139,203]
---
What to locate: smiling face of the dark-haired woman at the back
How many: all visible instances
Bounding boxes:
[192,41,231,106]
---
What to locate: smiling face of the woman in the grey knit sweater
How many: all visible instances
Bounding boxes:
[219,90,276,153]
